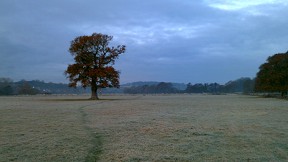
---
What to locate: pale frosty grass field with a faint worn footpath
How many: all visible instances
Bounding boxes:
[0,95,288,162]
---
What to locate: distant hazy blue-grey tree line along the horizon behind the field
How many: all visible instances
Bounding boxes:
[0,78,255,96]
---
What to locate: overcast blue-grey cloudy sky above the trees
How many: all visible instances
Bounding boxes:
[0,0,288,83]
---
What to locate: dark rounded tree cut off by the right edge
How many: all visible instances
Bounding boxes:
[255,52,288,96]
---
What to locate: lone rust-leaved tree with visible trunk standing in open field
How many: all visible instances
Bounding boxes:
[65,33,125,100]
